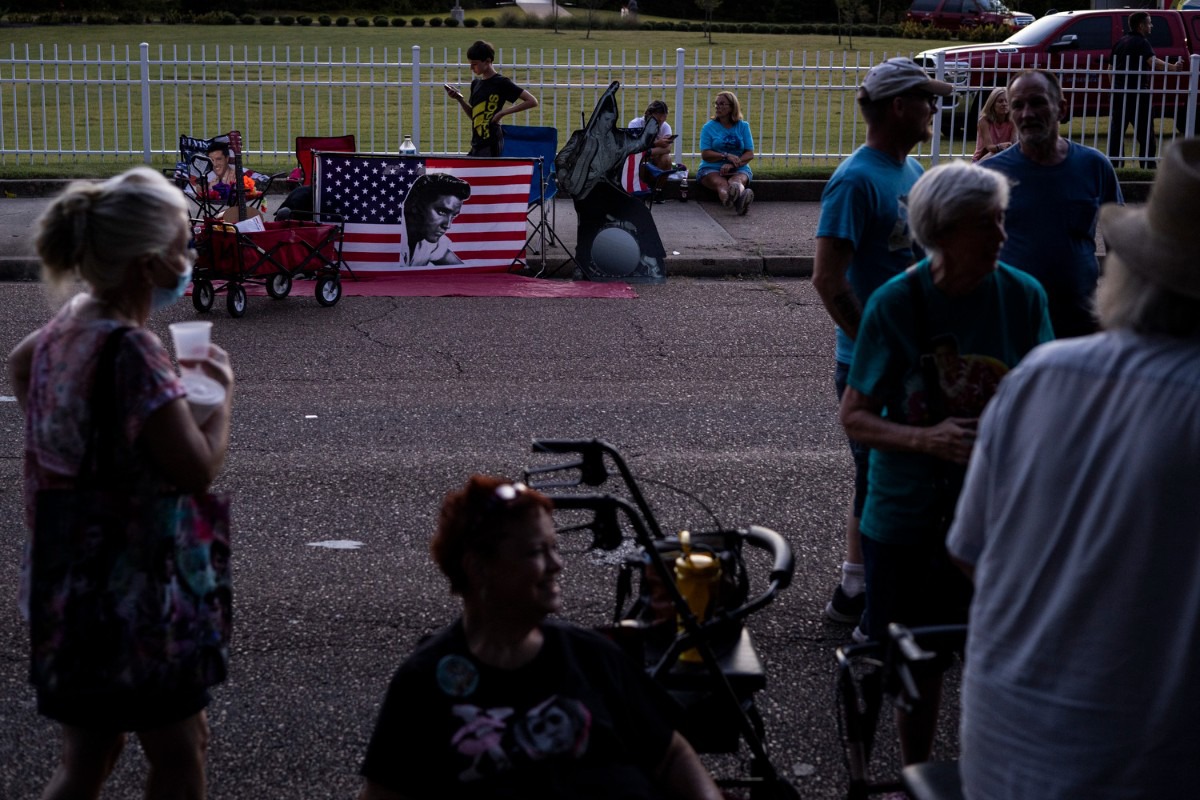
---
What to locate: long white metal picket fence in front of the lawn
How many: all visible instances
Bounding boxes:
[0,43,1200,167]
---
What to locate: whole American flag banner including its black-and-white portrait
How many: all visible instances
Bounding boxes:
[313,152,533,276]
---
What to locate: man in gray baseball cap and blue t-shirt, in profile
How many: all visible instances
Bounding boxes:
[812,58,954,638]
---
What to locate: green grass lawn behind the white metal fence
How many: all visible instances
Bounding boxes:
[0,20,1152,178]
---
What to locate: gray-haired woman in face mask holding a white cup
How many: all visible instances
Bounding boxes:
[8,167,233,800]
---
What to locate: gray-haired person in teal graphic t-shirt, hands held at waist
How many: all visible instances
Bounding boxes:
[841,163,1052,763]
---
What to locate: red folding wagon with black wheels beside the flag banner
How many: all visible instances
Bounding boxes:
[192,218,343,317]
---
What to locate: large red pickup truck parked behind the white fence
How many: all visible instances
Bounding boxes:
[913,8,1200,137]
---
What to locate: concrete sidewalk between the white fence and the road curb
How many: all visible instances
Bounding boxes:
[0,181,821,281]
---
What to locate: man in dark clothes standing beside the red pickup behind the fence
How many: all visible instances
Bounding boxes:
[1109,11,1184,169]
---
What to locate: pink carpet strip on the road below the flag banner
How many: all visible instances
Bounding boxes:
[212,272,637,300]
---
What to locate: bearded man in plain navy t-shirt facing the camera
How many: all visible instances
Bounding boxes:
[979,70,1124,338]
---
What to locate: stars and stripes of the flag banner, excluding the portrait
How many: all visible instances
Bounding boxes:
[313,152,534,276]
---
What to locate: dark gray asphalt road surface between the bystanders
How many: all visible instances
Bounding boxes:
[0,277,954,800]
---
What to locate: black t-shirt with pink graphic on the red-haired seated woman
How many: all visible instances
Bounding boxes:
[362,621,673,800]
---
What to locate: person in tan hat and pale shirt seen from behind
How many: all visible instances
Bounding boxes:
[947,139,1200,800]
